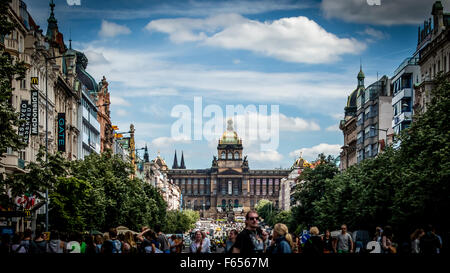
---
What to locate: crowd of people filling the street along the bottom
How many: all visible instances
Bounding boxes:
[0,211,442,254]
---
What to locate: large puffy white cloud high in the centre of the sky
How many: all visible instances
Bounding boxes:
[146,14,366,64]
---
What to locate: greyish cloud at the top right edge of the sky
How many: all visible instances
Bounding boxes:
[321,0,449,26]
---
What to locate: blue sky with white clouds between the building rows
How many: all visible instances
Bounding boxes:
[25,0,450,169]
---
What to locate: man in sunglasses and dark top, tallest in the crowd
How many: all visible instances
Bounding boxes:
[233,210,264,254]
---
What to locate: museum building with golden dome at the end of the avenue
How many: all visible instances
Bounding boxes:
[168,120,289,218]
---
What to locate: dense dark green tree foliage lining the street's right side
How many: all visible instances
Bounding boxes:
[291,76,450,235]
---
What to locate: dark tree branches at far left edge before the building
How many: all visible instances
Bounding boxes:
[0,0,27,157]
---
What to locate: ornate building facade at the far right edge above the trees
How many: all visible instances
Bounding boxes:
[414,1,450,113]
